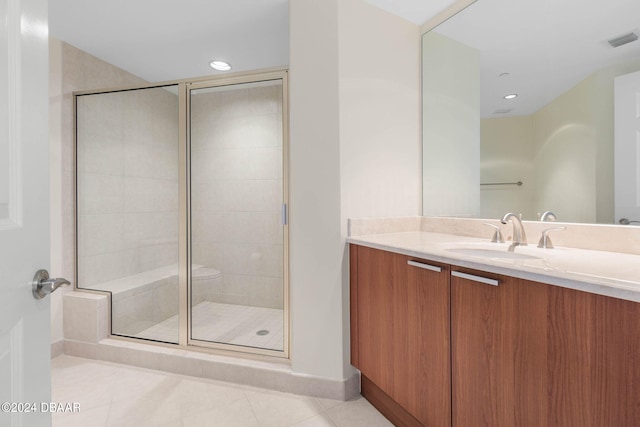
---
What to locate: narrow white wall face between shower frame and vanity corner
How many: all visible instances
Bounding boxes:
[289,0,346,379]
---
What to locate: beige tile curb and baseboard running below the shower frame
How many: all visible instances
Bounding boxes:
[64,338,360,400]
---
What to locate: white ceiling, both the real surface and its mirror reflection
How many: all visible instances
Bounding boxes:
[49,0,640,117]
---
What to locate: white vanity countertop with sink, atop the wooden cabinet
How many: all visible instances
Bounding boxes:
[347,231,640,302]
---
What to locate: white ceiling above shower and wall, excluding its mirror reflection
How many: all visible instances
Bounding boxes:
[49,0,453,82]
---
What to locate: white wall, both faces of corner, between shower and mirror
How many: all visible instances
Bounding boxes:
[289,0,421,379]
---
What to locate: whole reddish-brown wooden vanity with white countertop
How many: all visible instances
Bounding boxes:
[349,222,640,427]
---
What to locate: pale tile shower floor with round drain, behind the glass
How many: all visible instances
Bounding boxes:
[136,301,284,350]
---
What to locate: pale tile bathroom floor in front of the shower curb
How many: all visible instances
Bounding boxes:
[52,355,392,427]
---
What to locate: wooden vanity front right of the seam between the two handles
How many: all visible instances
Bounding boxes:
[451,267,640,427]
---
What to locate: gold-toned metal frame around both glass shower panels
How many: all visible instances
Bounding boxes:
[73,68,291,359]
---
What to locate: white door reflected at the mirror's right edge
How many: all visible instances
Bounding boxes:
[614,72,640,225]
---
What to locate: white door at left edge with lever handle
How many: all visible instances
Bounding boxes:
[0,0,51,427]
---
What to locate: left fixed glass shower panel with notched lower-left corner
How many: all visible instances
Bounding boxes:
[76,85,180,344]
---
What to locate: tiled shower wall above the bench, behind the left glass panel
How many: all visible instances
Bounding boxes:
[78,86,179,292]
